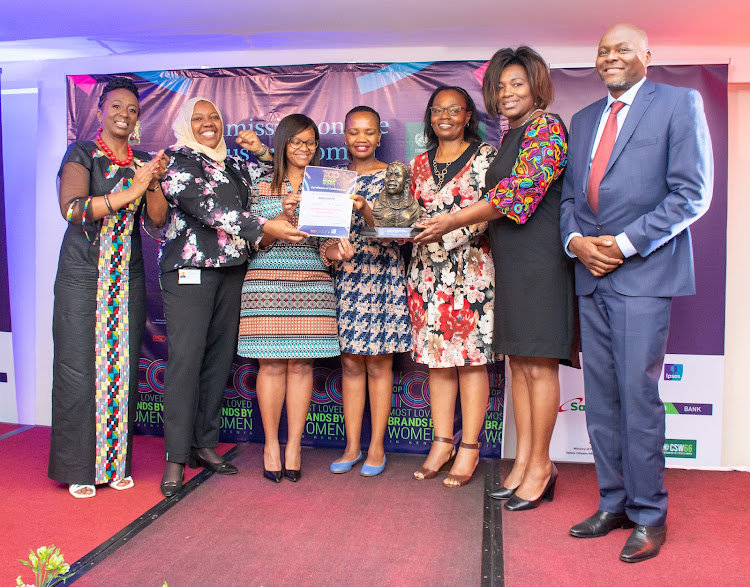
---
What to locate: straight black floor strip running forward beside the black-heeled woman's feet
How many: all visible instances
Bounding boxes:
[481,459,505,587]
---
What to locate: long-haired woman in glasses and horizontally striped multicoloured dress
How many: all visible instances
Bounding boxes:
[237,114,353,483]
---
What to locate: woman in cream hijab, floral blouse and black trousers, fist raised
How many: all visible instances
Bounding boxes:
[159,98,307,497]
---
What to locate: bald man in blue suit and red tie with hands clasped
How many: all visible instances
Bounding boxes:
[560,24,713,562]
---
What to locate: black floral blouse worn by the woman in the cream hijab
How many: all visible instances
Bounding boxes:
[159,147,272,273]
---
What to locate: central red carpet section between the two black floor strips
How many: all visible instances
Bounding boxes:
[76,444,484,586]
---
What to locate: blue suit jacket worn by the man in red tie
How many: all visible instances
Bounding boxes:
[560,79,713,297]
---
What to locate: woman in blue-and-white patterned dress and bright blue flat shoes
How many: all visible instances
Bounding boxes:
[331,106,411,477]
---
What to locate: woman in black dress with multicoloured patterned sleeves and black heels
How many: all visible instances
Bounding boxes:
[417,47,578,510]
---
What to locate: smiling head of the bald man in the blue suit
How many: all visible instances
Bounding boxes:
[596,25,651,98]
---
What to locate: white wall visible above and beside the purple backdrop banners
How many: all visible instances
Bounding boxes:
[0,42,750,466]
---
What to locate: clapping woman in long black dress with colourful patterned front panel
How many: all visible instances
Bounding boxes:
[48,78,167,498]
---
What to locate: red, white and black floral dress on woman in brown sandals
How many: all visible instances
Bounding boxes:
[408,143,496,368]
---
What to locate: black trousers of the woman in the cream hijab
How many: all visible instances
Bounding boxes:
[161,263,245,463]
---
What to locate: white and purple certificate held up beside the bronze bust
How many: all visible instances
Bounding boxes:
[298,165,357,238]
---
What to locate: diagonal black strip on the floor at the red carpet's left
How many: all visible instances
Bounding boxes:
[65,445,238,585]
